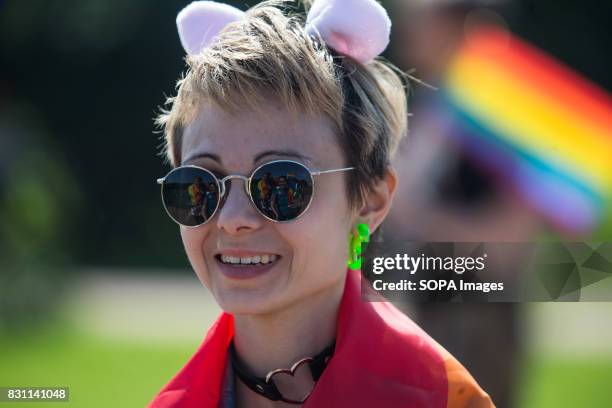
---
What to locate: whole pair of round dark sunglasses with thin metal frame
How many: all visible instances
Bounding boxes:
[157,160,354,227]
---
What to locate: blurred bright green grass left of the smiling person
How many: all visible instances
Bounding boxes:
[0,322,197,408]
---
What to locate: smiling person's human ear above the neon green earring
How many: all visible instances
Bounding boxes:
[358,167,397,233]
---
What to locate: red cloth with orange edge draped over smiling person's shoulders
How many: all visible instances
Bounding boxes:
[149,270,494,408]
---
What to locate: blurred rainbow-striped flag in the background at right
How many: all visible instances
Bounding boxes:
[441,28,612,232]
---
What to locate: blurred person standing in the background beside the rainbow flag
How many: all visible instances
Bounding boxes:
[383,0,542,408]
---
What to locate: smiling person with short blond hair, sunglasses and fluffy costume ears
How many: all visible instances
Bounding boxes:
[149,0,493,408]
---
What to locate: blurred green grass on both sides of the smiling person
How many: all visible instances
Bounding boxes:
[0,323,612,408]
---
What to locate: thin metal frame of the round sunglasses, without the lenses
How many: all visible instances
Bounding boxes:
[157,159,355,228]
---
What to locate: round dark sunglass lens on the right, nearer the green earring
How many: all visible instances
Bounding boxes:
[250,162,312,221]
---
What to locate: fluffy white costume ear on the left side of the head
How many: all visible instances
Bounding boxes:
[176,1,245,55]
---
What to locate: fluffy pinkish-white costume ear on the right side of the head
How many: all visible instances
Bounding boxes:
[306,0,391,63]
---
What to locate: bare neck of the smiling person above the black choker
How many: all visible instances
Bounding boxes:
[234,279,344,377]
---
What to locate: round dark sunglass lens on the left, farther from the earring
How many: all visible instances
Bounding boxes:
[162,167,219,227]
